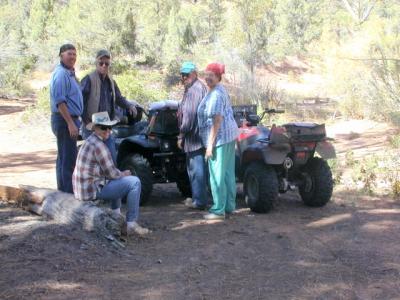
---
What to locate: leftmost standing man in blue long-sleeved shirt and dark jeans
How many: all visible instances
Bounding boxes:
[50,44,83,193]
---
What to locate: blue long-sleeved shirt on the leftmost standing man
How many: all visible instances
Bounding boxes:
[50,64,83,116]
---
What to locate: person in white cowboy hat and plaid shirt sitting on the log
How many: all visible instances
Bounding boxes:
[72,112,150,235]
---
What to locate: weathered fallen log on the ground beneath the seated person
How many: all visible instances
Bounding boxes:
[0,186,123,239]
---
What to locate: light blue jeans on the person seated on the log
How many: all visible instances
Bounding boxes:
[97,176,141,222]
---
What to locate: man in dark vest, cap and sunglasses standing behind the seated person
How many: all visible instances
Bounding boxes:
[81,49,137,162]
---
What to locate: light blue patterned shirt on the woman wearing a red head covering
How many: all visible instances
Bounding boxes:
[197,84,239,147]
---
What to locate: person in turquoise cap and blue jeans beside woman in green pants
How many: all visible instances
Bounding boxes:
[178,61,207,210]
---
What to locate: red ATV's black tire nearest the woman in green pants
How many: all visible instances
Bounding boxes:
[243,163,279,213]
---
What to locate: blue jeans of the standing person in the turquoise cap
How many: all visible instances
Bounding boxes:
[186,149,207,206]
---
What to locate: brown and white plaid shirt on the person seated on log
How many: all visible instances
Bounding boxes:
[72,133,122,200]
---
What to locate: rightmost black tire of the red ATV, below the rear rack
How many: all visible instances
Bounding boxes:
[299,157,333,207]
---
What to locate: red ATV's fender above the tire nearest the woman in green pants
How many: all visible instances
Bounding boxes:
[242,142,290,165]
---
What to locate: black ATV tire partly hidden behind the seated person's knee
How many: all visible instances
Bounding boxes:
[121,154,153,204]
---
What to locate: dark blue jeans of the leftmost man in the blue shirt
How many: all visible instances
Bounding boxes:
[51,113,80,193]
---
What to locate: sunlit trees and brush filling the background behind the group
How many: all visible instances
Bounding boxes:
[0,0,400,124]
